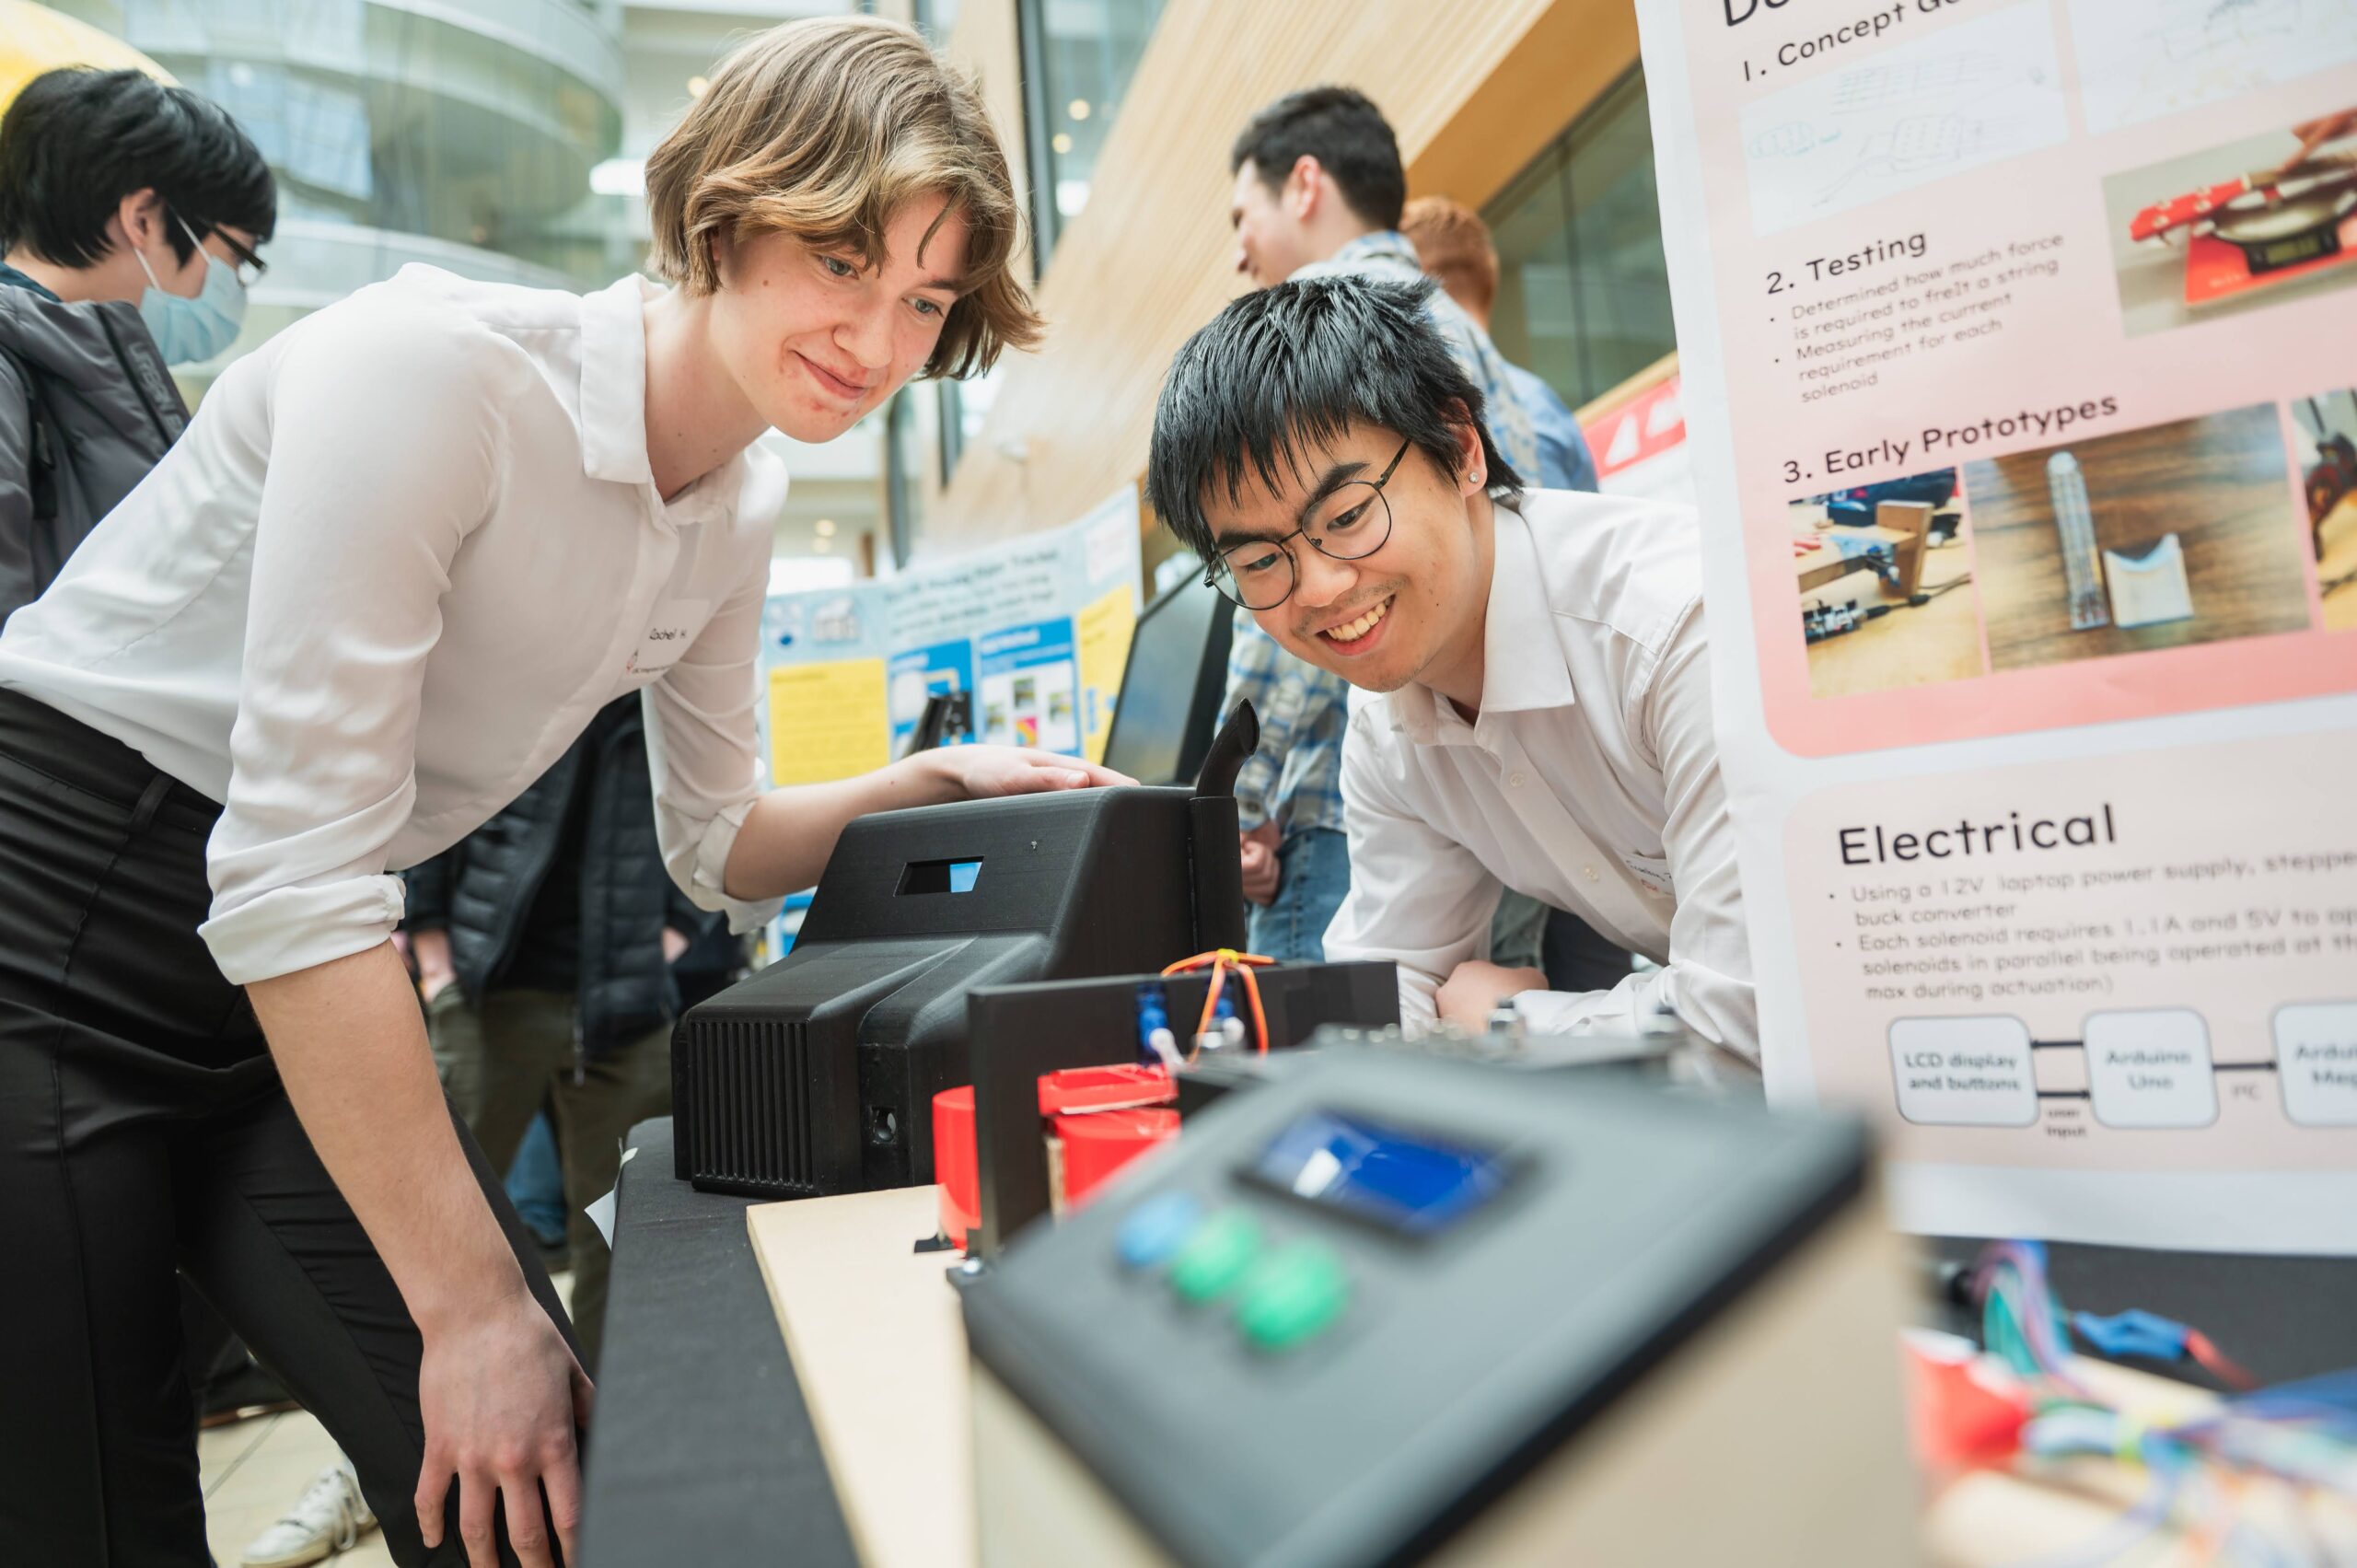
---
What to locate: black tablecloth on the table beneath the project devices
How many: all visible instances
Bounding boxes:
[582,1118,2357,1568]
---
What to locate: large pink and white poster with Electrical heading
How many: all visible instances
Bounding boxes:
[1638,0,2357,1252]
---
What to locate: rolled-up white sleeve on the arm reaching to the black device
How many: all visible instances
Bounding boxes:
[644,532,784,934]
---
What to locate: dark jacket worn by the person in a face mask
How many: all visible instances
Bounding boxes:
[0,268,189,621]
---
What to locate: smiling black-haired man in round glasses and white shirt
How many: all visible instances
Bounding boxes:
[1145,276,1759,1056]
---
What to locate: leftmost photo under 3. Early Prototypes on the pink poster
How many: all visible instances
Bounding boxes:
[1786,470,1990,698]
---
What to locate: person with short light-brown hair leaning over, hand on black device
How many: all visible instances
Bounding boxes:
[0,17,1120,1568]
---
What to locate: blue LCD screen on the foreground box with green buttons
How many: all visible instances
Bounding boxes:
[1251,1110,1514,1236]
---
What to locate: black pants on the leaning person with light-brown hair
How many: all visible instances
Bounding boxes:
[0,691,571,1568]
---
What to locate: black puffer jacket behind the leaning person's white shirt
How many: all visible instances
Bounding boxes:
[401,695,714,1056]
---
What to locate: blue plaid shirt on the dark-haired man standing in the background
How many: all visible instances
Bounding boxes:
[1221,228,1541,840]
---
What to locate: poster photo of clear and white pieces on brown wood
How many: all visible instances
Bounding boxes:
[1963,403,2312,669]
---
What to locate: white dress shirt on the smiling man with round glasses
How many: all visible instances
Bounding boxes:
[1325,491,1759,1056]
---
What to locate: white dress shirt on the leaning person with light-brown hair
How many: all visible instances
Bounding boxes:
[0,266,784,983]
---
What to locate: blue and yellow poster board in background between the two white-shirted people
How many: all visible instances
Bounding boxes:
[761,488,1141,783]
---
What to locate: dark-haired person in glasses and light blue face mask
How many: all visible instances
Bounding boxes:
[0,66,278,621]
